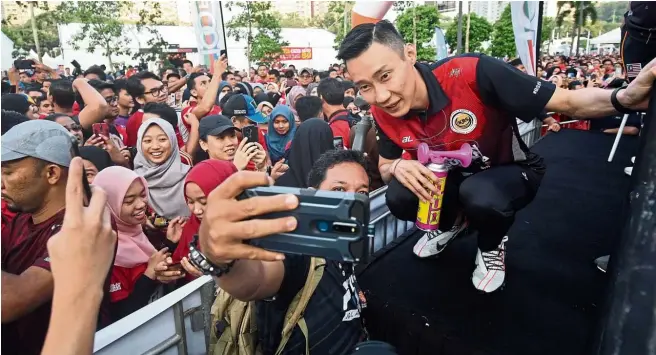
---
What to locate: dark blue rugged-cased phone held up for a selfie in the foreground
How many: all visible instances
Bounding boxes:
[238,186,371,263]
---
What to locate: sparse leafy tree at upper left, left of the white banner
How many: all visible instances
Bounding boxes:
[50,1,168,68]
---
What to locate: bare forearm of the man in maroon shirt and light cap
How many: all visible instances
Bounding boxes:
[2,266,54,323]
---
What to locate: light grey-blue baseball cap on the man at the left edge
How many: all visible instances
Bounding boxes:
[1,120,73,167]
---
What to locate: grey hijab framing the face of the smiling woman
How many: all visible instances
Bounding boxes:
[134,118,190,219]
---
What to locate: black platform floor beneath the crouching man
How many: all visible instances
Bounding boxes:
[358,130,637,355]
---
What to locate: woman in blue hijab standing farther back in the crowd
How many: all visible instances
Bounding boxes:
[267,105,296,164]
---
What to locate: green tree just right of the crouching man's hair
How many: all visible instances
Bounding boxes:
[395,5,440,60]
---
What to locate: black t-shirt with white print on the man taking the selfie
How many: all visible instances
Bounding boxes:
[257,255,366,355]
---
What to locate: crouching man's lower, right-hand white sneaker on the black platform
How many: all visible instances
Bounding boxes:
[472,236,508,293]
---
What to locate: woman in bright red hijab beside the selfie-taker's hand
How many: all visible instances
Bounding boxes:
[171,159,237,278]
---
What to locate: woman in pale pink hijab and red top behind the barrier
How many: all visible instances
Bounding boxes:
[94,166,184,320]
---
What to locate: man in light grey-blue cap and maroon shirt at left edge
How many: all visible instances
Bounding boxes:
[2,120,93,355]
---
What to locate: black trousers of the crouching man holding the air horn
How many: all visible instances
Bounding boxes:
[386,164,544,251]
